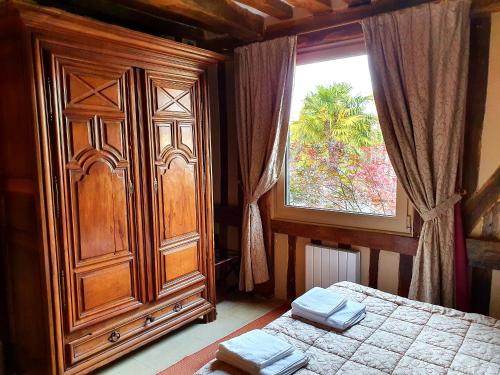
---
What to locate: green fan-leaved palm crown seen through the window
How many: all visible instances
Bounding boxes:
[291,83,382,160]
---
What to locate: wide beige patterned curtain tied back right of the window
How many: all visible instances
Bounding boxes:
[362,0,471,306]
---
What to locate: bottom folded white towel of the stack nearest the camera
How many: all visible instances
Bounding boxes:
[216,350,308,375]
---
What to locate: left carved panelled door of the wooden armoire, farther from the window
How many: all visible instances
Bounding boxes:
[46,54,143,331]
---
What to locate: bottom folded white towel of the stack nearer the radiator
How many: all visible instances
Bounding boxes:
[292,300,366,331]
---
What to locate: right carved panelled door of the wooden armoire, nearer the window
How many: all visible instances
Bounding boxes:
[146,72,206,298]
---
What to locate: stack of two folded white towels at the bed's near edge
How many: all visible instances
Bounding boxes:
[215,329,307,375]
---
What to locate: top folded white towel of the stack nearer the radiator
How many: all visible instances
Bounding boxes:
[292,287,346,318]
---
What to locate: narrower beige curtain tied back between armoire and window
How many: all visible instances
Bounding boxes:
[235,37,297,291]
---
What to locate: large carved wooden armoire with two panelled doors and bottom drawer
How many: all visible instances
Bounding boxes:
[0,1,222,374]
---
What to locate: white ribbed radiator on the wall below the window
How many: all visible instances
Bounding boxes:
[306,244,361,291]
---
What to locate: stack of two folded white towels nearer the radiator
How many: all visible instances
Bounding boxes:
[292,288,366,331]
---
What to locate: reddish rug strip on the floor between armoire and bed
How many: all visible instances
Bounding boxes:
[158,304,290,375]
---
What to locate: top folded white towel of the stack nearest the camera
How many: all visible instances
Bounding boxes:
[215,329,293,374]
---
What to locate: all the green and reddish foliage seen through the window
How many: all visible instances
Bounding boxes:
[288,83,396,215]
